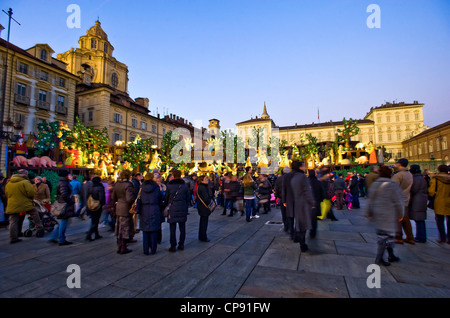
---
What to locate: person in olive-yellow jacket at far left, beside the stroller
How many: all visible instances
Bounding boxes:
[5,169,44,244]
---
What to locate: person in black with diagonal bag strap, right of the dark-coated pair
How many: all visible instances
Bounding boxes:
[196,176,212,242]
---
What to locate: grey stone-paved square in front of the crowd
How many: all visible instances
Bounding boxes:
[0,198,450,298]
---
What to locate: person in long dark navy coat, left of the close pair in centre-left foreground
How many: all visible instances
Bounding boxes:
[138,173,163,255]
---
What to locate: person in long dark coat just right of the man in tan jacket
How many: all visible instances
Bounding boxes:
[408,165,428,243]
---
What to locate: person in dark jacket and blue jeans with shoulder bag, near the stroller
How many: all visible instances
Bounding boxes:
[49,170,75,246]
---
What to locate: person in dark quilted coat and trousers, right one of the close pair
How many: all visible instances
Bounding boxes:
[164,170,191,252]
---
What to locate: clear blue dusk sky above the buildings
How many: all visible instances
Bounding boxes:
[0,0,450,129]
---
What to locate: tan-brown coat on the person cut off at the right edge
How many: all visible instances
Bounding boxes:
[428,173,450,215]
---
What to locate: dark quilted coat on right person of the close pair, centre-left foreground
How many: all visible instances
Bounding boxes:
[164,179,191,223]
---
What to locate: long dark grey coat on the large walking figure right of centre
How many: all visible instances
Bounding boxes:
[286,172,319,231]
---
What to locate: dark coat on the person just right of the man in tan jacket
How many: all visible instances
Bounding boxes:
[408,173,428,221]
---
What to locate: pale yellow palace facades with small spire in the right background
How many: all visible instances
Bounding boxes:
[236,101,428,159]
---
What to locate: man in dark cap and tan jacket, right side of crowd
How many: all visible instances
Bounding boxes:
[392,158,414,244]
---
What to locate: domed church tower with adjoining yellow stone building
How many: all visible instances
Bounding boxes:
[58,21,176,146]
